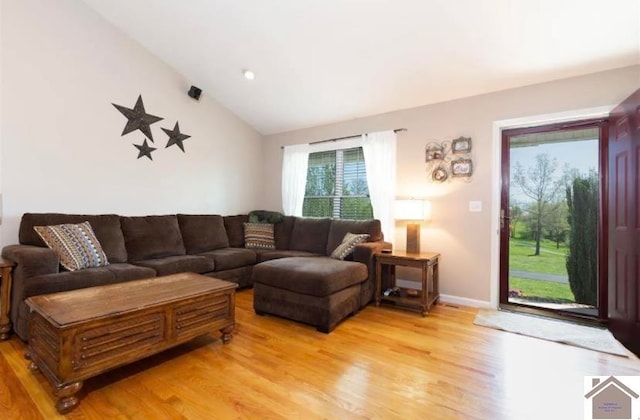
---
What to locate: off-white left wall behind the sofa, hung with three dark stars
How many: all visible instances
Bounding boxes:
[0,0,262,245]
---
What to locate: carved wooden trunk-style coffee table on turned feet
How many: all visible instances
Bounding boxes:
[25,273,238,414]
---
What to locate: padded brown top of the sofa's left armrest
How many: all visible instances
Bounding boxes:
[2,245,60,281]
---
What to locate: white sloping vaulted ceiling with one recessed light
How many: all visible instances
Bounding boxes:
[84,0,640,134]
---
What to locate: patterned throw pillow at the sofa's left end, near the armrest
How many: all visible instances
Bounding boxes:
[33,222,109,271]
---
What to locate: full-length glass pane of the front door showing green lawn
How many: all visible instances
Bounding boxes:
[508,127,599,316]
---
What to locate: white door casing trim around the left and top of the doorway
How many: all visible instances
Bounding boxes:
[488,104,616,309]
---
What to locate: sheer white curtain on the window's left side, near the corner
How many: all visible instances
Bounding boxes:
[282,144,309,216]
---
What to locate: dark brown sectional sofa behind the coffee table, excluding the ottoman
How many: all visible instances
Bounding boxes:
[2,213,391,340]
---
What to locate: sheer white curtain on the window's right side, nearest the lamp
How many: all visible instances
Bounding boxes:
[362,130,396,242]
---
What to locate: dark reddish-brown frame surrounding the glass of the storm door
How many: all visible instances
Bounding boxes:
[499,117,609,320]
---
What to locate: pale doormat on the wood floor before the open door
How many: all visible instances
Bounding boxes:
[473,309,629,357]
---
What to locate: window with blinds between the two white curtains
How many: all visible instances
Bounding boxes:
[302,147,373,219]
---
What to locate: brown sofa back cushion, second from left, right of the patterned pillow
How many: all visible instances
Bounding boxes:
[120,215,186,261]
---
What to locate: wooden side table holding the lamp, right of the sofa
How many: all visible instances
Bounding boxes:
[375,251,440,316]
